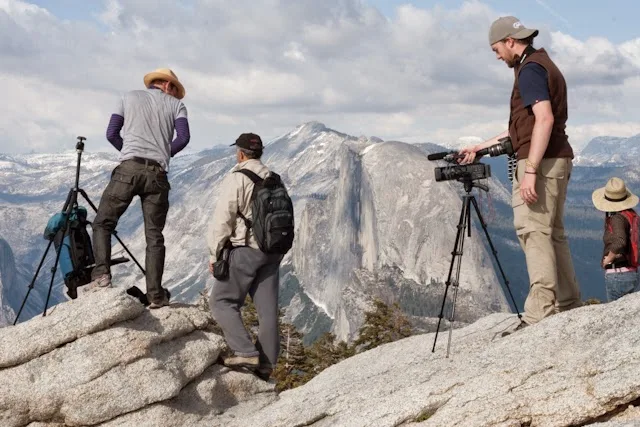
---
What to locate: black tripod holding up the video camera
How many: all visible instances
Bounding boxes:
[431,177,522,358]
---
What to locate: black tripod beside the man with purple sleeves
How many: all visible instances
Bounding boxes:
[13,136,145,325]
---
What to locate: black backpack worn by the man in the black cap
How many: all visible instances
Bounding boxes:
[236,169,294,255]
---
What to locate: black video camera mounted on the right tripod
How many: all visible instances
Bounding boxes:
[427,136,513,181]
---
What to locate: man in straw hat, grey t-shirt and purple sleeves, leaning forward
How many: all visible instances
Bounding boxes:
[87,68,190,308]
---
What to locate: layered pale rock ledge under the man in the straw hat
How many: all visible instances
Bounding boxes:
[0,289,273,427]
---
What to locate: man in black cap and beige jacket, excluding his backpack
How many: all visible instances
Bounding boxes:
[207,133,283,380]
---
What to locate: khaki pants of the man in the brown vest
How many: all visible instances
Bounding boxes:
[512,158,581,324]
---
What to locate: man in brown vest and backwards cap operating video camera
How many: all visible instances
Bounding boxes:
[460,16,581,329]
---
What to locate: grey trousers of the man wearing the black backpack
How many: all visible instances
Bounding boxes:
[209,247,282,368]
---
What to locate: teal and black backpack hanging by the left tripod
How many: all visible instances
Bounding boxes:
[44,206,95,299]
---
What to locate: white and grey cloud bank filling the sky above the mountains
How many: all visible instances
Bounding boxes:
[0,0,640,152]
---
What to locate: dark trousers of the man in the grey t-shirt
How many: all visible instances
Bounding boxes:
[91,160,171,302]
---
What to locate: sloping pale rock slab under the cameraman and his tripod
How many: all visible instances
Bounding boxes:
[224,294,640,427]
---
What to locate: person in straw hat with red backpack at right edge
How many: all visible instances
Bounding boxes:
[591,177,640,301]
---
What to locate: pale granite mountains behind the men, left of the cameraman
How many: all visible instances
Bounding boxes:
[0,122,508,339]
